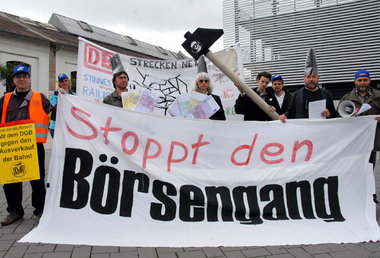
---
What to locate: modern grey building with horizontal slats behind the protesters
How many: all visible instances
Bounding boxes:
[223,0,380,99]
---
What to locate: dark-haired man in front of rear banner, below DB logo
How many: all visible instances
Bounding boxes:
[103,71,129,107]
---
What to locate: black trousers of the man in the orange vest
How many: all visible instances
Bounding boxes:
[3,143,46,215]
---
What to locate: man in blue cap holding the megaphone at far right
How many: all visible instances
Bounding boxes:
[339,70,380,167]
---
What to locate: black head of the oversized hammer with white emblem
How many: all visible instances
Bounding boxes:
[182,28,223,60]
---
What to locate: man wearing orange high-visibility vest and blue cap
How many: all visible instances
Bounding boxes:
[0,65,53,226]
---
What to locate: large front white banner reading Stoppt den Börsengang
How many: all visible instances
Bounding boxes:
[20,95,380,247]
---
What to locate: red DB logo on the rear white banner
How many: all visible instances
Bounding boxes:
[84,43,115,74]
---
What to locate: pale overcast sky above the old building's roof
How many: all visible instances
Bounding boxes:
[0,0,223,54]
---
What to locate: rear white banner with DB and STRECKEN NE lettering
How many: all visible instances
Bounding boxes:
[77,38,243,120]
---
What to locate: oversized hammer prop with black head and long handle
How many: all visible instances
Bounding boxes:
[182,28,279,120]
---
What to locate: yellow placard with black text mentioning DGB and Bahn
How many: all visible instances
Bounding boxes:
[0,123,40,184]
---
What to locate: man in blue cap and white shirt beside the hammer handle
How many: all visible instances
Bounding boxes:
[272,74,292,115]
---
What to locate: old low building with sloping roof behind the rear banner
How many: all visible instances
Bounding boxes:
[0,11,185,96]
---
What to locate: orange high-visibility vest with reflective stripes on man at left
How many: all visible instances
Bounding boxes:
[1,91,49,143]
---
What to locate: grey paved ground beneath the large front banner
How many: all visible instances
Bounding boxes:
[0,136,380,258]
